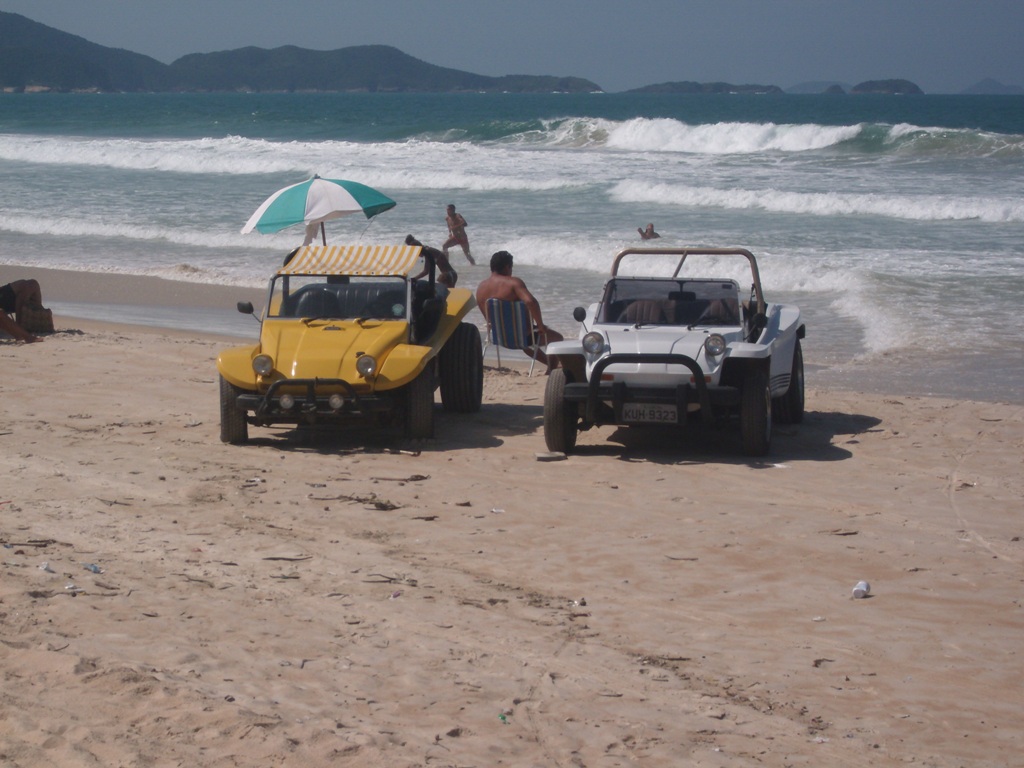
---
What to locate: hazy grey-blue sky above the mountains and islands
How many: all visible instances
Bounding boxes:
[0,0,1024,93]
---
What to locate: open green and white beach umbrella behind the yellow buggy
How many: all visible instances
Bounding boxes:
[242,176,397,244]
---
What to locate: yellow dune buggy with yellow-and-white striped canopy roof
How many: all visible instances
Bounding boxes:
[217,238,483,443]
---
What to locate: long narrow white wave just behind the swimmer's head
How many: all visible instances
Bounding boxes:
[609,180,1024,222]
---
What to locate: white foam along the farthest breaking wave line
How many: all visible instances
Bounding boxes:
[0,117,1024,183]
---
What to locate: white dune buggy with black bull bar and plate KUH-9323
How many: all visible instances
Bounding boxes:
[544,248,805,456]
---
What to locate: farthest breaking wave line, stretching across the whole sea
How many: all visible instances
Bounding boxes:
[0,118,1024,182]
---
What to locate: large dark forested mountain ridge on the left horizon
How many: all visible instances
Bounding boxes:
[0,12,601,93]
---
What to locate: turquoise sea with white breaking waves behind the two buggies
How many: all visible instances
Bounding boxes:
[0,94,1024,402]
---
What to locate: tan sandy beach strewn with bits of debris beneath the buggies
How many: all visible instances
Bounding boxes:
[0,273,1024,768]
